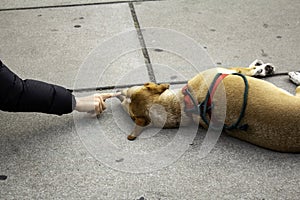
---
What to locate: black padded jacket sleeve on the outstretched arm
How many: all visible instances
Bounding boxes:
[0,61,75,115]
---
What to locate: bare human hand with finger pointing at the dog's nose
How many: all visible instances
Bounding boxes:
[75,93,118,115]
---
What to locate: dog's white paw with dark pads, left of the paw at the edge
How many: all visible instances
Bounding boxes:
[249,59,276,76]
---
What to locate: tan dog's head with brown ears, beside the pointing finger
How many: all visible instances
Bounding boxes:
[118,82,170,127]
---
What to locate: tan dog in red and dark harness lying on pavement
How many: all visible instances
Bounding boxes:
[119,60,300,152]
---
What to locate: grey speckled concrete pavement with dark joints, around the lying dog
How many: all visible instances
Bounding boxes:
[0,0,300,199]
